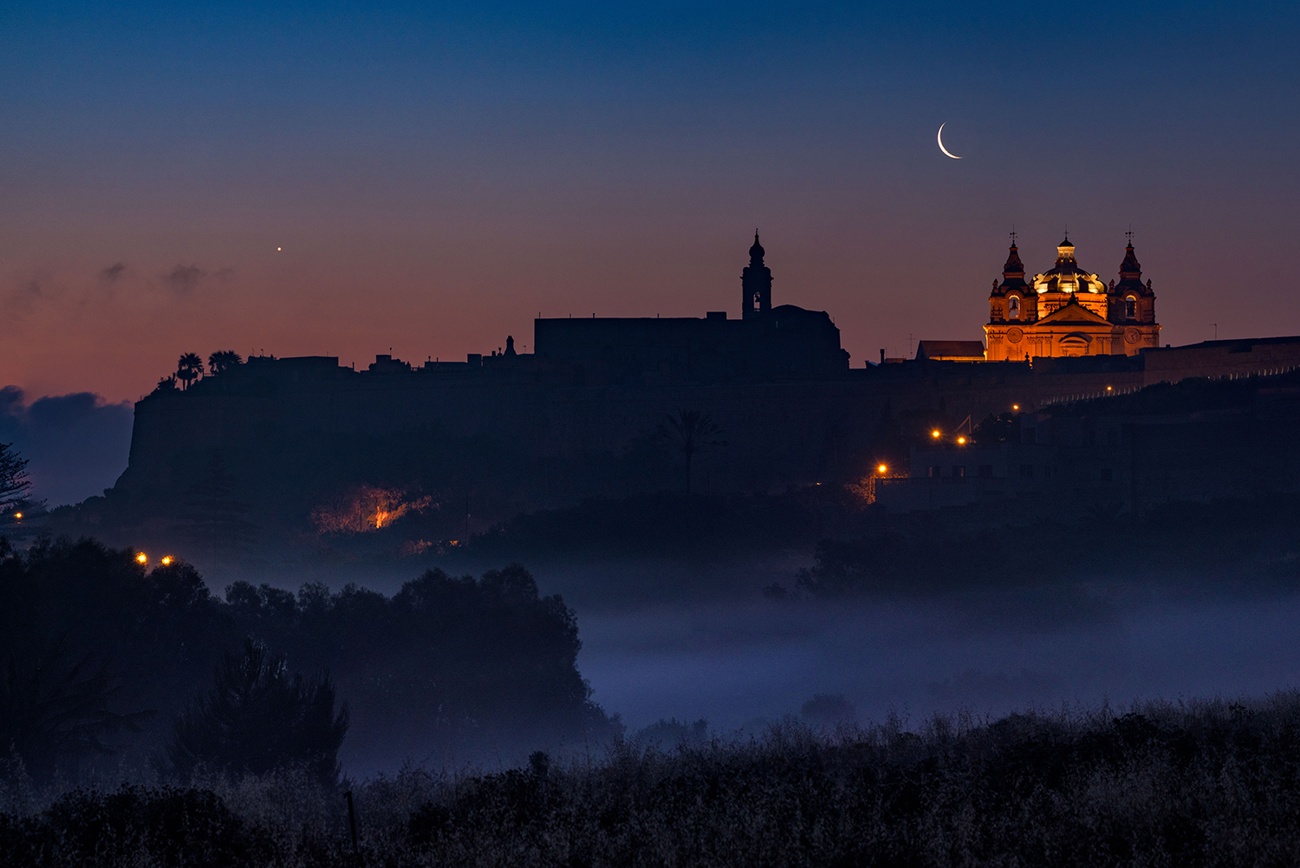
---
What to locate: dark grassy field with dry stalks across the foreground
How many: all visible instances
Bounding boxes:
[0,694,1300,865]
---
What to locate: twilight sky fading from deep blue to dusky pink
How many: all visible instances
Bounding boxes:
[0,0,1300,402]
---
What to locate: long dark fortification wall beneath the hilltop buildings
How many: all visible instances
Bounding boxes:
[116,342,1300,530]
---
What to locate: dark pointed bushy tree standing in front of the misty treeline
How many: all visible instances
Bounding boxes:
[168,639,348,786]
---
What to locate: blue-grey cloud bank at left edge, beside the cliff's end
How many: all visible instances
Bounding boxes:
[0,386,131,507]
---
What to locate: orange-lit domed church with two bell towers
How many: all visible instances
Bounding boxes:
[984,233,1160,361]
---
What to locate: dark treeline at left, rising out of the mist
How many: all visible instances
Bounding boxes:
[0,538,611,781]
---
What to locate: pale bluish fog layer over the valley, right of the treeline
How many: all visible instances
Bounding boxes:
[579,589,1300,732]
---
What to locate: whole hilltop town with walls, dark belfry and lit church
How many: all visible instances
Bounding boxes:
[53,231,1300,553]
